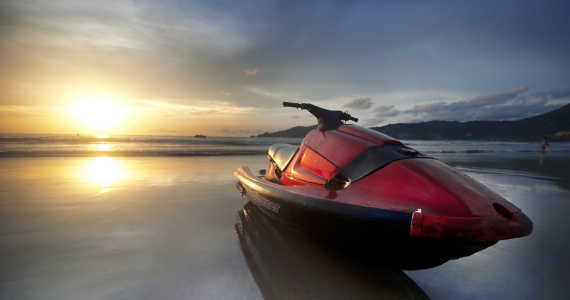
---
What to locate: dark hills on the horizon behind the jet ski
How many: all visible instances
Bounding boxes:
[257,104,570,141]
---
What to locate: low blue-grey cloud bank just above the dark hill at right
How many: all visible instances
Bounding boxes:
[403,87,570,122]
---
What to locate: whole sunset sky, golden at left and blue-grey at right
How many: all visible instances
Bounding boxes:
[0,0,570,136]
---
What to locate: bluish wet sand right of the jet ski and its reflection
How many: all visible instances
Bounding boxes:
[405,152,570,299]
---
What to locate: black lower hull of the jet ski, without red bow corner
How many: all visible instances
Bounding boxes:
[234,167,504,260]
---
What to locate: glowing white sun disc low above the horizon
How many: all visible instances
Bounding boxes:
[72,95,125,130]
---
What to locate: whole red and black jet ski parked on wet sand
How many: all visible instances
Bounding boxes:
[234,102,533,259]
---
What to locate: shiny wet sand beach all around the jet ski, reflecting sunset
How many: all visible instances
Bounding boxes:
[0,153,570,299]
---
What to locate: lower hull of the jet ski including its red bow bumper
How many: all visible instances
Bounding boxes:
[234,167,533,259]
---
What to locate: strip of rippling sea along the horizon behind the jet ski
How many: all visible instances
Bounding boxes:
[0,133,570,157]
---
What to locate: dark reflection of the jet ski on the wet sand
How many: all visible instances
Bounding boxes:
[235,202,428,299]
